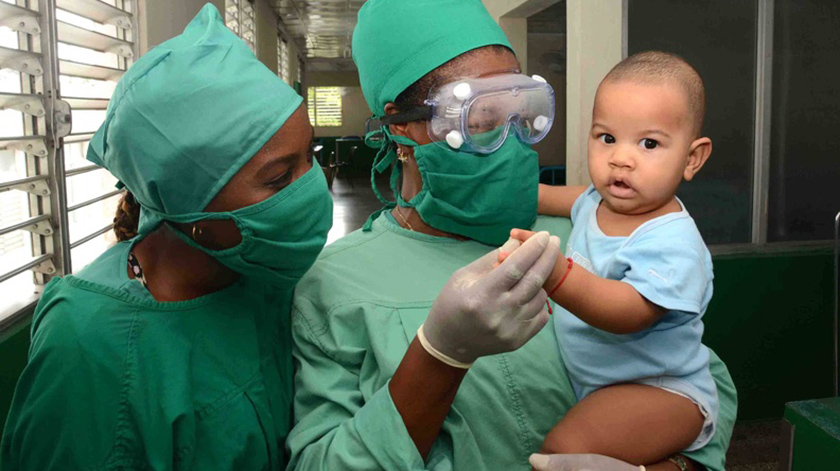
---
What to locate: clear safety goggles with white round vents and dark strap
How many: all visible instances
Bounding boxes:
[379,74,554,154]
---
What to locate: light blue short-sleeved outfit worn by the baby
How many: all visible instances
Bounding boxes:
[554,186,716,404]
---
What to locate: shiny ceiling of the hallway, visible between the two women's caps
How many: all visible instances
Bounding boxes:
[272,0,365,68]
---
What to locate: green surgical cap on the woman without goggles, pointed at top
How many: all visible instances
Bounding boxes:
[87,4,303,215]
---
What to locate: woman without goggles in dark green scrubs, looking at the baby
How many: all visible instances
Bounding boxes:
[0,5,332,471]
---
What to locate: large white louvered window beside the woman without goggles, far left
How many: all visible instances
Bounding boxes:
[0,0,136,328]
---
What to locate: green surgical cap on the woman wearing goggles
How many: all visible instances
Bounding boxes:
[353,0,513,116]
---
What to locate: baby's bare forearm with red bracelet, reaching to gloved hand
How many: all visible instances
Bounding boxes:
[510,229,666,334]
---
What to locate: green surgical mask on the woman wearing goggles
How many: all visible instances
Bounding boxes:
[365,132,539,246]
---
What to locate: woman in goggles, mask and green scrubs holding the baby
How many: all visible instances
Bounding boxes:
[288,0,737,471]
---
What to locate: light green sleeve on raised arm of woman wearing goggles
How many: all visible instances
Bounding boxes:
[287,304,425,471]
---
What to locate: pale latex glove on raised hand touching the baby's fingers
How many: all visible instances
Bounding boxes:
[419,232,560,366]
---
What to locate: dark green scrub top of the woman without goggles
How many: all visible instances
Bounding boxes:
[0,242,292,471]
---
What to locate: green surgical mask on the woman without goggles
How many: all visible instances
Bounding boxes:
[141,165,332,286]
